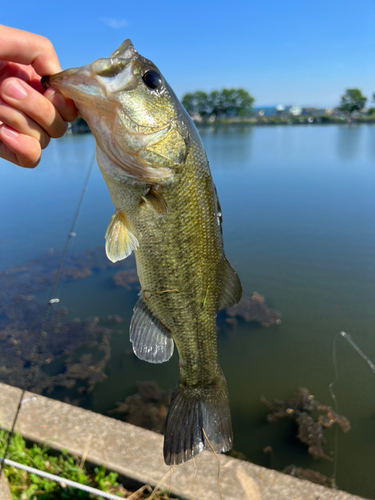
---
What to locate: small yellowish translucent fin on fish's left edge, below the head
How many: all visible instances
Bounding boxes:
[105,210,139,262]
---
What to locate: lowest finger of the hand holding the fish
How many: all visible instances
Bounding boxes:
[0,124,41,168]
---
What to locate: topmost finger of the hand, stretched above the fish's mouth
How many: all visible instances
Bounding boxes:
[0,25,61,76]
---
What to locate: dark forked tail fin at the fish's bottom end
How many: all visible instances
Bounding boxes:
[164,375,233,465]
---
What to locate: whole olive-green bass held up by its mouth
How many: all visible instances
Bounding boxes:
[42,40,242,465]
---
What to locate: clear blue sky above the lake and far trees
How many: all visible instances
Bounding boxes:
[1,0,375,106]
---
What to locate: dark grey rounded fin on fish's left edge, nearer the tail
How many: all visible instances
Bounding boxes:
[130,295,174,363]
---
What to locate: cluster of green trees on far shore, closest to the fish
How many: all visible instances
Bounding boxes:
[182,88,255,121]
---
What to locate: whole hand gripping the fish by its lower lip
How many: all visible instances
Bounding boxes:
[0,25,77,168]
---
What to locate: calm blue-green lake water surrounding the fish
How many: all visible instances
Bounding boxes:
[0,125,375,498]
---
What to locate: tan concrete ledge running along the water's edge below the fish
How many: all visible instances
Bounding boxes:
[0,383,368,500]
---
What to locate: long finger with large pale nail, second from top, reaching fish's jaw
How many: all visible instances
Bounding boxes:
[0,78,67,138]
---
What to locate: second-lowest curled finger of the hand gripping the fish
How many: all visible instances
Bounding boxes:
[0,94,50,149]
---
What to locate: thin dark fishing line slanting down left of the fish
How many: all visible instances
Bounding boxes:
[0,152,95,475]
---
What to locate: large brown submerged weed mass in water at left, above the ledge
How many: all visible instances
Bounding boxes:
[0,249,131,404]
